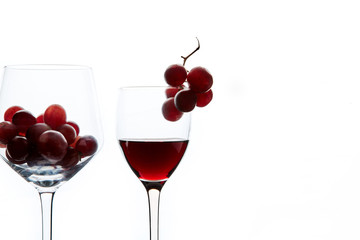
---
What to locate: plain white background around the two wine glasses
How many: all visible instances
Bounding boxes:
[0,0,360,240]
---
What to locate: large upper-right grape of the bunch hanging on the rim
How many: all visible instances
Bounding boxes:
[187,67,213,93]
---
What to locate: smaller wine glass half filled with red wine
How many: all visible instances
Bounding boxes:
[117,87,191,240]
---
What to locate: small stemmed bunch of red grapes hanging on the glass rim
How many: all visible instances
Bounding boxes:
[162,40,213,121]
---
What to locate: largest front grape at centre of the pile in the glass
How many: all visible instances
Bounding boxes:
[36,130,68,160]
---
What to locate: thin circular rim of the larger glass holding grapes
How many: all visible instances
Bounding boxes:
[4,64,91,70]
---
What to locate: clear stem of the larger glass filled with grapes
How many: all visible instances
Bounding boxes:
[39,192,55,240]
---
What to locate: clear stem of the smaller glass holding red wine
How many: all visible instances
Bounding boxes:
[147,188,160,240]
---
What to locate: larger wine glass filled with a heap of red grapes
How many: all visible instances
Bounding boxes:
[0,65,103,240]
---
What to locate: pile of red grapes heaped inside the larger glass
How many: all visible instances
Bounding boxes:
[0,104,98,168]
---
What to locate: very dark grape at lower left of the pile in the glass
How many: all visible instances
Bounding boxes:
[7,136,29,161]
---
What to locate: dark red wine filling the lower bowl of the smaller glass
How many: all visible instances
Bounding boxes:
[119,139,189,181]
